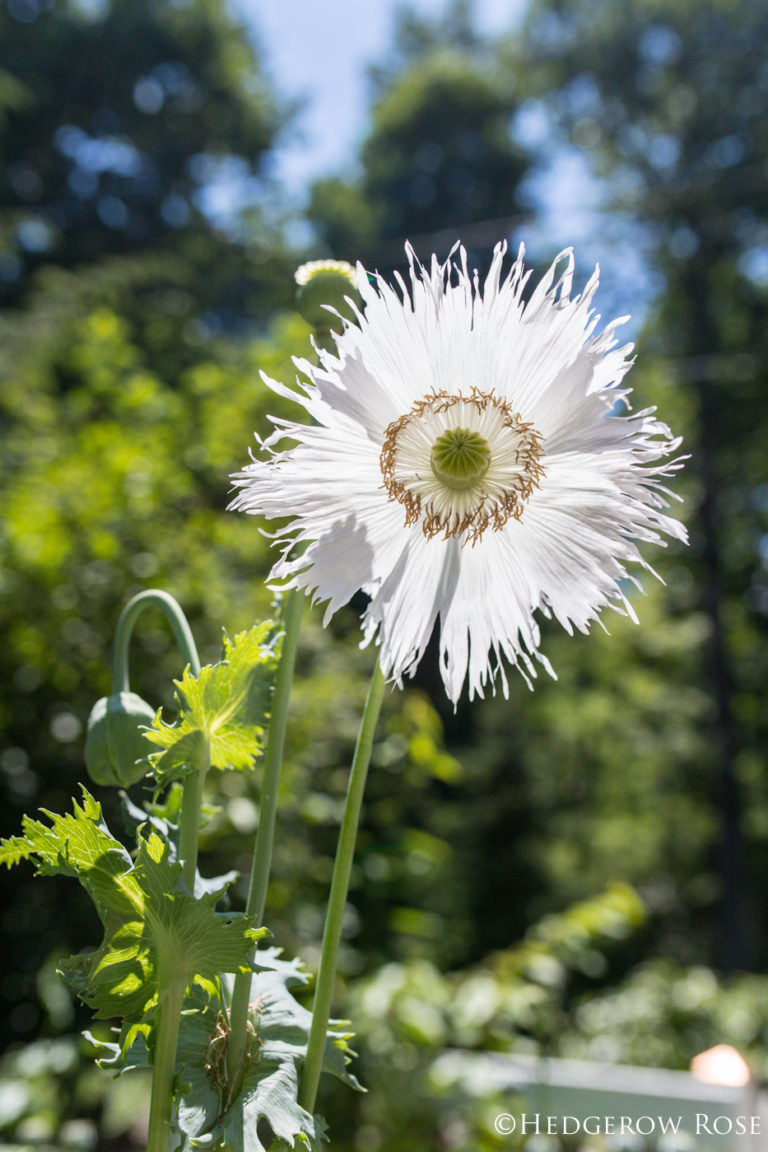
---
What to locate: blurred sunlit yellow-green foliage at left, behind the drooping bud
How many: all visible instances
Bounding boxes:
[0,294,291,1046]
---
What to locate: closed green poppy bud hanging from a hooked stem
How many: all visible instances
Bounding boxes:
[85,692,154,788]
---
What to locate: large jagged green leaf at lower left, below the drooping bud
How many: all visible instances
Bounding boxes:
[4,789,266,1021]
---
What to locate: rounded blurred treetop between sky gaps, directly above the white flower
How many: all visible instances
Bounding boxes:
[309,0,529,272]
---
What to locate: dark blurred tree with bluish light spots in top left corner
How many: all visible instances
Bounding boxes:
[0,0,292,323]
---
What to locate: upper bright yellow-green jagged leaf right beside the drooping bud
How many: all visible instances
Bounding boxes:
[146,621,277,783]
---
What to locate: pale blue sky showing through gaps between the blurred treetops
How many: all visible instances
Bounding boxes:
[225,0,654,335]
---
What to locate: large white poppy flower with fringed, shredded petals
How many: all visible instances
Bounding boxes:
[231,244,686,702]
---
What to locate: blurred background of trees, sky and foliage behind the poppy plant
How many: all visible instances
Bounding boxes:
[0,0,768,1152]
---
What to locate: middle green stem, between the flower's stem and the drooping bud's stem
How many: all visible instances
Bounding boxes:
[227,589,304,1100]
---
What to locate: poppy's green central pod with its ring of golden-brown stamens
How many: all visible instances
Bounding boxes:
[380,388,545,544]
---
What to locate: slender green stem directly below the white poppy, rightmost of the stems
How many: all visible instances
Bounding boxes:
[298,662,385,1112]
